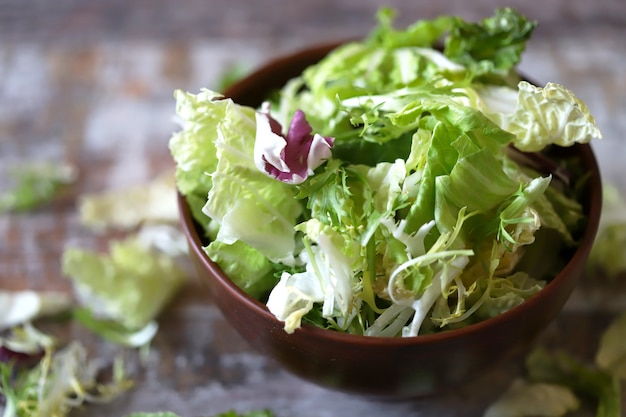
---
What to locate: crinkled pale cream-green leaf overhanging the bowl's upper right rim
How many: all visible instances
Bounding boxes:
[479,81,602,152]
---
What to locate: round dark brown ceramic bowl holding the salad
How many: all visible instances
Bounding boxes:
[174,44,601,399]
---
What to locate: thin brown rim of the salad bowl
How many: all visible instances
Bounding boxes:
[176,41,602,347]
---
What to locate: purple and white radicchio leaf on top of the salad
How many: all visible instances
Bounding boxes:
[254,102,334,184]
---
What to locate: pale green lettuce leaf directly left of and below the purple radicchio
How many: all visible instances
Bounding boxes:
[190,94,302,263]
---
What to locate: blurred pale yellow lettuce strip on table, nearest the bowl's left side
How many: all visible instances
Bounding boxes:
[79,172,179,231]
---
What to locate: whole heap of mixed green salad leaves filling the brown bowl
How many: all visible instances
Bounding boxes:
[170,8,601,336]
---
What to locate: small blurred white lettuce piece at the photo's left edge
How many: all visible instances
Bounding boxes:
[0,290,73,331]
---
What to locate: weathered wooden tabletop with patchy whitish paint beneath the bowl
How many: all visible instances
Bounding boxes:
[0,0,626,417]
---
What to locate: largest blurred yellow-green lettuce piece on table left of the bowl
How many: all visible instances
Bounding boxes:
[62,228,187,330]
